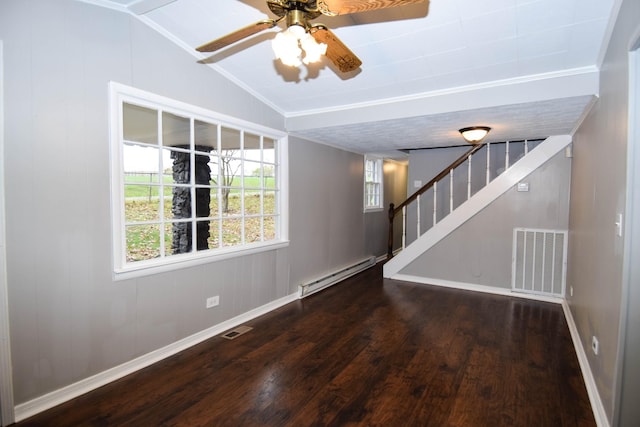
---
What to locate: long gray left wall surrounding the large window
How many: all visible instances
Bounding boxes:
[0,0,386,404]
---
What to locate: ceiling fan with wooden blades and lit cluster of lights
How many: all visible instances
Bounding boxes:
[196,0,424,73]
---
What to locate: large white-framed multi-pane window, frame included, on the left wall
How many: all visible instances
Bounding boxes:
[111,83,287,277]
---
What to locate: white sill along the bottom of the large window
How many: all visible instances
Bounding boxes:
[113,240,289,281]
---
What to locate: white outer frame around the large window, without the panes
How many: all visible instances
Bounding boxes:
[109,82,289,280]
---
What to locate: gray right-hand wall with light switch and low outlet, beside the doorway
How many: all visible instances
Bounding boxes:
[568,0,640,420]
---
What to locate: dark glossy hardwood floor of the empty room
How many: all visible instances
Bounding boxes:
[17,265,595,427]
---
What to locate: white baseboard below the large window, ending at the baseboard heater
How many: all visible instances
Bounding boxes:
[14,293,298,422]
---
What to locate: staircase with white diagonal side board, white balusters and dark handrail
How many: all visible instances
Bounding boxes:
[383,135,571,278]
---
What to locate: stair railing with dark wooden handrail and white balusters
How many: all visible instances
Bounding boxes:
[387,140,540,259]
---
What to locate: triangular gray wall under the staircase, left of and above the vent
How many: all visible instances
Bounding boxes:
[400,151,571,288]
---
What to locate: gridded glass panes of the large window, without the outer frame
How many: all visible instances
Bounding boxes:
[117,92,280,270]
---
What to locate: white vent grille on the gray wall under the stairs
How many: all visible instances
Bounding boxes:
[511,228,568,297]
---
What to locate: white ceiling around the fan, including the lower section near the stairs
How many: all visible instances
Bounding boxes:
[92,0,617,153]
